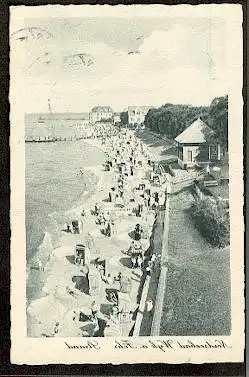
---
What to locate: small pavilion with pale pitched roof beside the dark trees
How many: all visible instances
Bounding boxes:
[175,118,221,169]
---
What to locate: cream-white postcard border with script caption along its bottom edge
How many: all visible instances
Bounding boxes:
[10,4,244,365]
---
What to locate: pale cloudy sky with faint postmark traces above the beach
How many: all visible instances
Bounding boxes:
[11,17,228,112]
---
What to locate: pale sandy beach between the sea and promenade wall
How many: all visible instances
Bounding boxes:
[27,130,167,337]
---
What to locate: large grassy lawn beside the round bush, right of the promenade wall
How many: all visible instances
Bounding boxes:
[160,191,230,335]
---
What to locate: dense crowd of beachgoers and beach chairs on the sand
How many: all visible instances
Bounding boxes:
[33,129,166,336]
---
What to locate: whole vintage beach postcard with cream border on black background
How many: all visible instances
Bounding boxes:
[10,4,244,365]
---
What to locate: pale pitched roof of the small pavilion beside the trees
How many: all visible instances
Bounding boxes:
[175,118,212,144]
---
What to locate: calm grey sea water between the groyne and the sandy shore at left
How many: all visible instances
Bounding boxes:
[25,140,104,260]
